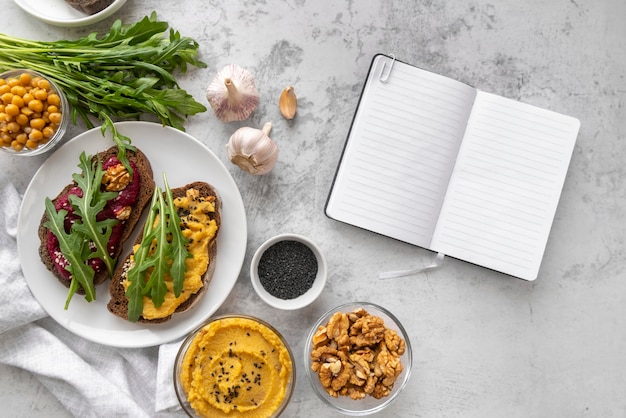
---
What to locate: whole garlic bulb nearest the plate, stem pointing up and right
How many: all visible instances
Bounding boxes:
[226,122,278,175]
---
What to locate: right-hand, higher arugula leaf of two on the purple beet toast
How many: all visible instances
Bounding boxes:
[69,151,119,276]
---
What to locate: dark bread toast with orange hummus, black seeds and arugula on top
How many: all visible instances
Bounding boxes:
[107,181,221,323]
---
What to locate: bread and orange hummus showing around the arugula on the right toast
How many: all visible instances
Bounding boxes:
[107,181,222,323]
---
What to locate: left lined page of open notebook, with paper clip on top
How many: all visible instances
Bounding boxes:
[326,55,476,248]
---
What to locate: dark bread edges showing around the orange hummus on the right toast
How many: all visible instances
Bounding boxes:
[107,181,222,324]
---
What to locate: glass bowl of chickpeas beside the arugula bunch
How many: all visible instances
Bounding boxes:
[0,69,71,156]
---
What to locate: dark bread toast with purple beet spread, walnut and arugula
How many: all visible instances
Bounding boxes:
[38,147,154,309]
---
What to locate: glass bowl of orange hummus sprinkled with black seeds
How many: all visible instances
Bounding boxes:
[174,315,296,418]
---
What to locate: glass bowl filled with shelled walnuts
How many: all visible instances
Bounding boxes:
[304,302,413,416]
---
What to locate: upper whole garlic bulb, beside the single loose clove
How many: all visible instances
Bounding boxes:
[206,64,259,122]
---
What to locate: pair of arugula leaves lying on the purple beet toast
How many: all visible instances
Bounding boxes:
[44,151,118,309]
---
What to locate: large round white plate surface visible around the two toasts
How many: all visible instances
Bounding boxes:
[17,122,247,347]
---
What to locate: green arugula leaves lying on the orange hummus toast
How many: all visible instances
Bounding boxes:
[126,174,192,322]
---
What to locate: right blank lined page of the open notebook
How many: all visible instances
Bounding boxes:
[433,92,580,280]
